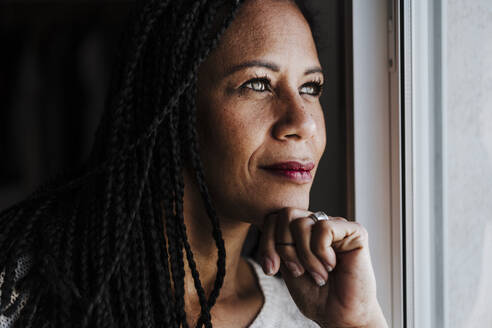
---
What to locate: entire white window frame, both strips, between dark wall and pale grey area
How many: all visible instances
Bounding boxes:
[353,0,447,328]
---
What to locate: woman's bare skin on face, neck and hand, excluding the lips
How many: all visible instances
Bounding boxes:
[184,0,387,328]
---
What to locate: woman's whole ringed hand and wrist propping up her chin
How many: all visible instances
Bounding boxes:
[260,208,387,328]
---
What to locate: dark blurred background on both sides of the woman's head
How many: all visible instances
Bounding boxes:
[0,0,354,218]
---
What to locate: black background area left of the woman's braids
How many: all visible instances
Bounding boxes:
[0,1,129,211]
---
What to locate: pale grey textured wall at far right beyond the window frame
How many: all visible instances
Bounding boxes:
[445,0,492,328]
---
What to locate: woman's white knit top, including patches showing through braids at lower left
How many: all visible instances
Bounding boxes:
[0,258,319,328]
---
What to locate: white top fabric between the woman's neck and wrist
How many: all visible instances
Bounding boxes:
[248,259,319,328]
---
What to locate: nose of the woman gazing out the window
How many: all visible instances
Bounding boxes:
[272,94,317,141]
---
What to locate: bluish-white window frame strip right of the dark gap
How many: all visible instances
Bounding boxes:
[402,0,448,328]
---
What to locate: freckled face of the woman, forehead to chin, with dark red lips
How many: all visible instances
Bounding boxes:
[197,0,326,224]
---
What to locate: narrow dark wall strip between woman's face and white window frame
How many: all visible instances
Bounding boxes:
[306,0,354,219]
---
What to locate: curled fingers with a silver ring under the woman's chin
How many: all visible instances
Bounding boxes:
[259,208,367,286]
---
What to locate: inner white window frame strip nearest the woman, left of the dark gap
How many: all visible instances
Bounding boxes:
[353,0,403,327]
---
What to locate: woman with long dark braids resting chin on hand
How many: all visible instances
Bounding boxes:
[0,0,386,327]
